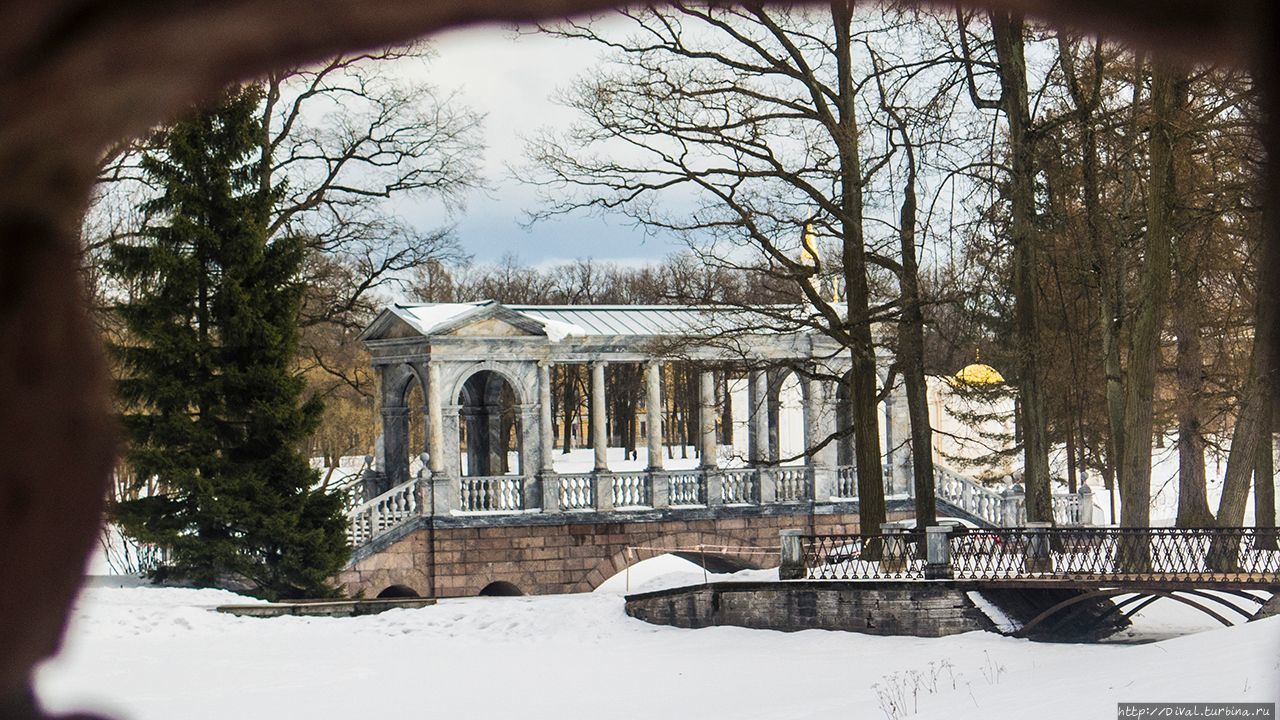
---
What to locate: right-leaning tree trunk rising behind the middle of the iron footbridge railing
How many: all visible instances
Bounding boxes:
[1120,63,1180,528]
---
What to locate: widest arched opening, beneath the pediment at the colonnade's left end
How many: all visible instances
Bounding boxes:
[458,370,524,477]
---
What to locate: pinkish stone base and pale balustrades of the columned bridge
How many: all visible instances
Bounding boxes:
[339,468,1093,597]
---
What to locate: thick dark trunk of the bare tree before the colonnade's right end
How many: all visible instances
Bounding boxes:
[831,0,886,538]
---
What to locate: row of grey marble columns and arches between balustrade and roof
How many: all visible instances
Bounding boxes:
[378,357,870,499]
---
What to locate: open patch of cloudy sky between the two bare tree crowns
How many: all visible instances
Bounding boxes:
[399,27,677,269]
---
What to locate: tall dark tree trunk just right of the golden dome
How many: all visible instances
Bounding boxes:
[991,13,1053,523]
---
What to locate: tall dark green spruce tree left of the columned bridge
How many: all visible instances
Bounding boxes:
[110,86,347,598]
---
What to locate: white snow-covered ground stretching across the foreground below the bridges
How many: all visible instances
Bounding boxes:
[37,556,1280,720]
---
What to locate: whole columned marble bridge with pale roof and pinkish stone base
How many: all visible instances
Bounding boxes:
[339,301,1093,597]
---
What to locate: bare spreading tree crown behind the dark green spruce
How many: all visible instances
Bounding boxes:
[86,46,481,393]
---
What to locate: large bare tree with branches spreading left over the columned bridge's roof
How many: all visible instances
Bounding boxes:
[530,0,962,533]
